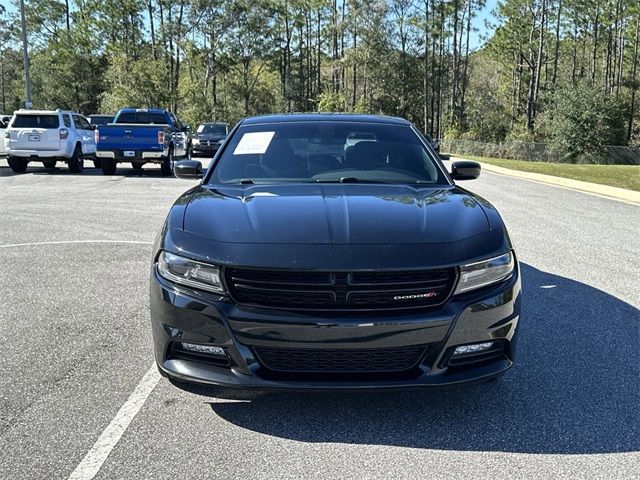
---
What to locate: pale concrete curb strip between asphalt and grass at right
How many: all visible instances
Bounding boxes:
[451,156,640,206]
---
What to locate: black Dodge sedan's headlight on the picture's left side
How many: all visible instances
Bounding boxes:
[158,251,224,293]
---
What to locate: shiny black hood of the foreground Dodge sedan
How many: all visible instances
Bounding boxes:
[183,184,490,245]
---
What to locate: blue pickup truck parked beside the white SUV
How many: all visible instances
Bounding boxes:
[95,108,191,176]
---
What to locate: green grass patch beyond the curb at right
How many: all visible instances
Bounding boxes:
[456,155,640,191]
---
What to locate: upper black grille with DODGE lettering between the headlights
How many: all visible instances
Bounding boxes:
[225,268,456,310]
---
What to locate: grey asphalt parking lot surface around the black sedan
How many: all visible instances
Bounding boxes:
[0,160,640,479]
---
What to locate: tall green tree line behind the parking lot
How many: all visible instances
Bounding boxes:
[0,0,640,156]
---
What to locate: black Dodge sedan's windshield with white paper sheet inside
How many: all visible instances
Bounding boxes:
[209,121,448,185]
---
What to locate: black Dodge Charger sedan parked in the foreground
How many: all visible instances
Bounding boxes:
[151,114,521,390]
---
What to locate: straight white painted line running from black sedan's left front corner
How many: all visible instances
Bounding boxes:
[69,362,160,480]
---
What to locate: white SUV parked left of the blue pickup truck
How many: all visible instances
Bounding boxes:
[4,110,96,173]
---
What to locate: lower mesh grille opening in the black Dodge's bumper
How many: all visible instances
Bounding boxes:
[254,346,425,373]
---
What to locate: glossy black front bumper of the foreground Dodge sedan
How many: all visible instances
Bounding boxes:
[151,267,521,390]
